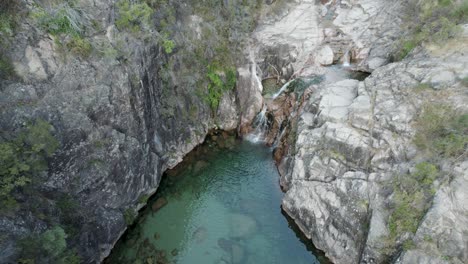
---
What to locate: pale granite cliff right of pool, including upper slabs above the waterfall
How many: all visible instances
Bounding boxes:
[256,1,468,263]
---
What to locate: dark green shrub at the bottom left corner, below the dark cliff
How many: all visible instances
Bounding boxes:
[18,225,81,264]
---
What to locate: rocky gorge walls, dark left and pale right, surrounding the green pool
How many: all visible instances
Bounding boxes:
[0,0,468,263]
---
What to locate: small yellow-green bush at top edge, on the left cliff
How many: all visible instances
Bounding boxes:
[115,0,153,33]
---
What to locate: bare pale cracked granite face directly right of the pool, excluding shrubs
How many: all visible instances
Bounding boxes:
[280,32,468,263]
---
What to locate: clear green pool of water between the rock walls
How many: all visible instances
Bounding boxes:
[106,142,324,264]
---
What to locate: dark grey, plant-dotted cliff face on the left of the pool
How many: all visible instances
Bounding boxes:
[0,1,261,263]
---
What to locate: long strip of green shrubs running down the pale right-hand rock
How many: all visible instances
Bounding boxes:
[382,103,468,256]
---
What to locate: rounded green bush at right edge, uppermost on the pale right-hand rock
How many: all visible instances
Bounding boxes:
[414,104,468,158]
